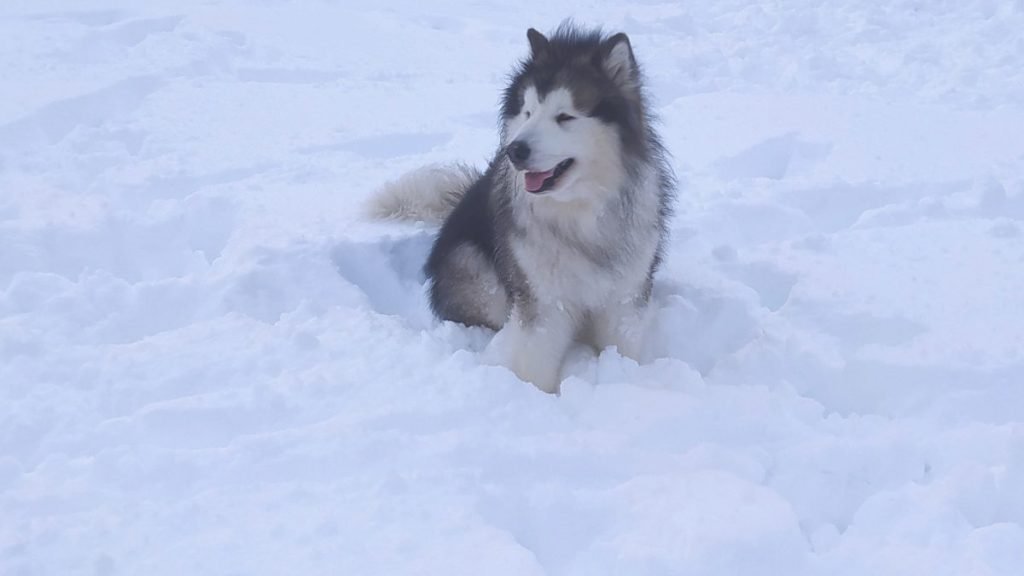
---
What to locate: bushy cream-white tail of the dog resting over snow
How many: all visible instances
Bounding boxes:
[367,164,480,223]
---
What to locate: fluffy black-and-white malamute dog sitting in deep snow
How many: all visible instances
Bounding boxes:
[371,23,676,393]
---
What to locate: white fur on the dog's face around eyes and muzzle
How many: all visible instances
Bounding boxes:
[504,86,625,202]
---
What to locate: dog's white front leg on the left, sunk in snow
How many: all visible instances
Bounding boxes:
[489,307,575,394]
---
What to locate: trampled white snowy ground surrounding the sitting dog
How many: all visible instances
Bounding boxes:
[0,0,1024,576]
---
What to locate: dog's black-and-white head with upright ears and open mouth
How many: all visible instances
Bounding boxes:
[502,25,646,200]
